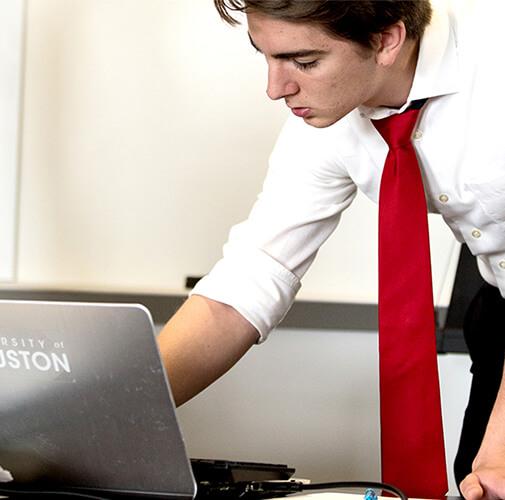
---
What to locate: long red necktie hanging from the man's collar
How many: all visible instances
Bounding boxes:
[373,109,447,498]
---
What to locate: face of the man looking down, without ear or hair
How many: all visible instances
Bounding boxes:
[247,13,380,127]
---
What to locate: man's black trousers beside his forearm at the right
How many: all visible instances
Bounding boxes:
[454,284,505,485]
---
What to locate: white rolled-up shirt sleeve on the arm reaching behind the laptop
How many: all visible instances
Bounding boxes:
[192,114,356,342]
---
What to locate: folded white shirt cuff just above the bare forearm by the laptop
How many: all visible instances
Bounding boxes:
[190,250,301,343]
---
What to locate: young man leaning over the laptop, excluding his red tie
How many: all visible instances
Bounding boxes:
[160,0,505,500]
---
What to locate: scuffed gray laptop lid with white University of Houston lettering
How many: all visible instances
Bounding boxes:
[0,301,195,499]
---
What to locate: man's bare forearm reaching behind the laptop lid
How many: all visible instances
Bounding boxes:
[158,295,258,405]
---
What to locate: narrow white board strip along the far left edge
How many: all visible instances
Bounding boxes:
[0,0,24,281]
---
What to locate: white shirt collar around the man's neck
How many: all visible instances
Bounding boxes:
[359,0,460,120]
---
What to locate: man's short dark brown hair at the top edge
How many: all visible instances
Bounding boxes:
[214,0,431,48]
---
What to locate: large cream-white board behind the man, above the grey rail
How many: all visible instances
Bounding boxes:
[9,0,457,304]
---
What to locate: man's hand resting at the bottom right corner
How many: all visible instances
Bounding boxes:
[459,460,505,500]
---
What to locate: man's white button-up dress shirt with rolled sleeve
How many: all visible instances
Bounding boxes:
[192,0,505,340]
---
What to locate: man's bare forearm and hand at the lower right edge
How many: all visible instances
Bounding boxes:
[460,369,505,500]
